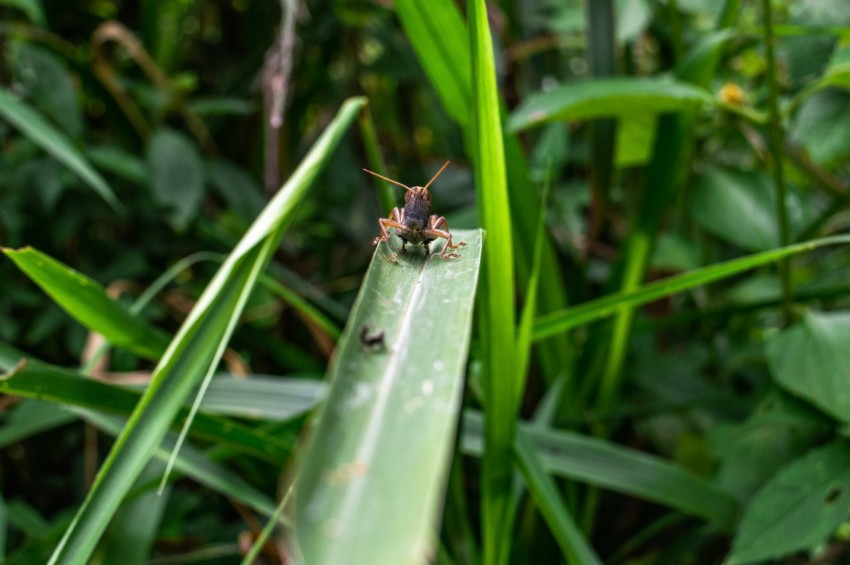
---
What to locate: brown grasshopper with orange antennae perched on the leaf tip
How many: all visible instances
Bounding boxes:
[363,161,466,259]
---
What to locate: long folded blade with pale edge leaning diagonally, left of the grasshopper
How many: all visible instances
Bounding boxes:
[45,99,364,564]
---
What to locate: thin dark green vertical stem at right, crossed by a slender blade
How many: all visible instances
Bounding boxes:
[762,0,792,324]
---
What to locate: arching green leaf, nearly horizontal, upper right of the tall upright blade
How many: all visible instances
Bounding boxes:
[507,78,713,132]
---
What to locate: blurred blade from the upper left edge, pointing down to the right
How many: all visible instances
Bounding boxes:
[0,88,123,211]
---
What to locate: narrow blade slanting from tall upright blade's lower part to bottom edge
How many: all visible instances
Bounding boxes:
[514,430,602,565]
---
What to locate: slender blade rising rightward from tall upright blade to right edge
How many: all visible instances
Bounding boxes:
[534,235,850,340]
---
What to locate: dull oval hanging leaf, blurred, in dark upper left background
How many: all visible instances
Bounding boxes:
[147,129,204,231]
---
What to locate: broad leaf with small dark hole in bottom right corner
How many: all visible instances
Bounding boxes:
[726,442,850,565]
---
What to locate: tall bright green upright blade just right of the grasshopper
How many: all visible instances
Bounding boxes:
[467,0,519,565]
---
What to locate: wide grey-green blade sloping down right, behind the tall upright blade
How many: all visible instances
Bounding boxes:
[461,410,738,529]
